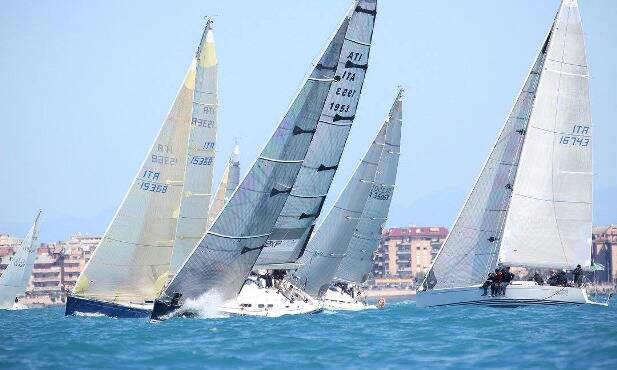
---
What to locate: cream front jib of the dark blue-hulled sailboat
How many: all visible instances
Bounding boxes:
[73,60,196,303]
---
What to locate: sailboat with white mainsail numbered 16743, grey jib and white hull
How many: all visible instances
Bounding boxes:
[417,0,604,307]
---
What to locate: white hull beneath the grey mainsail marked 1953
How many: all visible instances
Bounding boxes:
[219,280,323,317]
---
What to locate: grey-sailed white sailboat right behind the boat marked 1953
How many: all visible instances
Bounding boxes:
[290,90,403,310]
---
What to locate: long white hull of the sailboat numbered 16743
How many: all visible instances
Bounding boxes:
[416,281,607,307]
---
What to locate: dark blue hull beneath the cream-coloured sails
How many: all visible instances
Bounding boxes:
[64,295,151,319]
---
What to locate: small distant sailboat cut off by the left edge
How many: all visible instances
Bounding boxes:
[0,211,41,309]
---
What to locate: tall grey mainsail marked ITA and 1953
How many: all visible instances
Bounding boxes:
[255,1,376,269]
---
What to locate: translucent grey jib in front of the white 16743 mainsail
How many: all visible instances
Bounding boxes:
[423,18,551,289]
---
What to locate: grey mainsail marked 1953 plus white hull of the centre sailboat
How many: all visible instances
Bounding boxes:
[221,1,376,317]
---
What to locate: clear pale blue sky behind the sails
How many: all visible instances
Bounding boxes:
[0,0,617,242]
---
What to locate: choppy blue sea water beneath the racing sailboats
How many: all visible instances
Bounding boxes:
[0,300,617,369]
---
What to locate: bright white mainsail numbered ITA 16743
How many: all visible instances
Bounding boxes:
[499,0,592,269]
